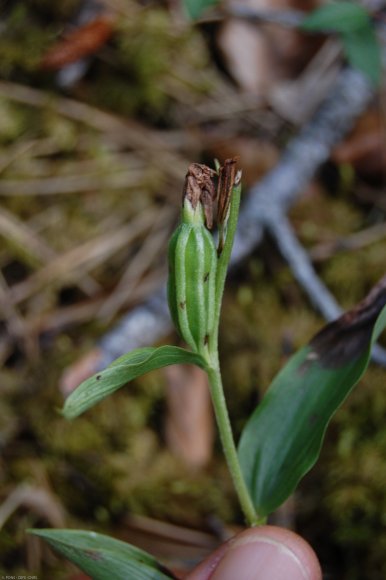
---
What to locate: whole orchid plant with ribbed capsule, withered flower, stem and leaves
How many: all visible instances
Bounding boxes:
[31,158,386,580]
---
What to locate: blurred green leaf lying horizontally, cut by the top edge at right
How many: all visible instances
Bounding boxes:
[301,2,371,33]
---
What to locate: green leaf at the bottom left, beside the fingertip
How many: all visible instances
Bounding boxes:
[28,529,174,580]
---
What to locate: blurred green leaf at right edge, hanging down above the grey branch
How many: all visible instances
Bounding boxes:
[342,25,382,86]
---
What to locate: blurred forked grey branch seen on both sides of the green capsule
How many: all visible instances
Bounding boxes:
[100,68,386,367]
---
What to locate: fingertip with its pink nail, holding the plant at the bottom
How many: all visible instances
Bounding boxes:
[186,526,322,580]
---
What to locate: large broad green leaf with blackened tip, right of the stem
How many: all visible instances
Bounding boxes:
[239,276,386,516]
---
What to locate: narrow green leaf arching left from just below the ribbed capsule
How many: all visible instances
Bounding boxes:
[62,346,206,419]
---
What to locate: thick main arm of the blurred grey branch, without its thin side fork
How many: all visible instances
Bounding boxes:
[234,68,373,261]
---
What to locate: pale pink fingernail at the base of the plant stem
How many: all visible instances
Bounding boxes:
[211,536,310,580]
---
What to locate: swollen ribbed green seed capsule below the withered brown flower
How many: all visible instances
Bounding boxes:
[168,223,217,355]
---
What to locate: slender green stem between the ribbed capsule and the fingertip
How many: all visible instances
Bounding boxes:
[207,361,264,526]
